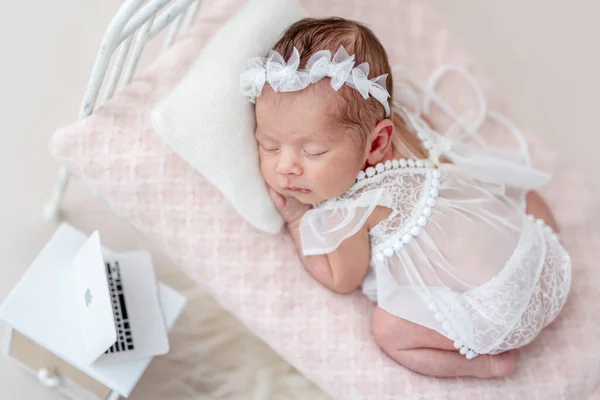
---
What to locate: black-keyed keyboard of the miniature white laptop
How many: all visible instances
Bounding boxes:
[106,261,135,354]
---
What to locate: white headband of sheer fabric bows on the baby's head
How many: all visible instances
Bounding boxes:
[240,46,391,117]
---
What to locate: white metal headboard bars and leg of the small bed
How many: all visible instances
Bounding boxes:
[44,0,202,220]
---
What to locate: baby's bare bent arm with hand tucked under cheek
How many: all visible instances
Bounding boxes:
[271,191,370,294]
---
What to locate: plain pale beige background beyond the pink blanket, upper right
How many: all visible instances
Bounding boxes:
[424,0,600,190]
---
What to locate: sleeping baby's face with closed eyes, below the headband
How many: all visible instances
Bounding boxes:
[256,84,367,204]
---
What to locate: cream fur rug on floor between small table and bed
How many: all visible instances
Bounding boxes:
[130,271,329,400]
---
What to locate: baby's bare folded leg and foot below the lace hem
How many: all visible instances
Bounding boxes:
[372,307,515,378]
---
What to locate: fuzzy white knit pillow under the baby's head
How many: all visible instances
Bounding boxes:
[152,0,306,233]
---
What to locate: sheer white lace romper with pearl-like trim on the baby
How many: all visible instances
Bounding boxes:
[300,134,571,359]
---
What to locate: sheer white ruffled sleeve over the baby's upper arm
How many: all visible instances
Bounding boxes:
[300,189,384,256]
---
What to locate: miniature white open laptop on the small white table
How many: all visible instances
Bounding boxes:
[72,232,169,363]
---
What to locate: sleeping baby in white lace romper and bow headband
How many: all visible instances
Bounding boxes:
[241,18,571,377]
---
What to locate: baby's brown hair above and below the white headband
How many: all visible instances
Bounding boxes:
[273,17,393,145]
